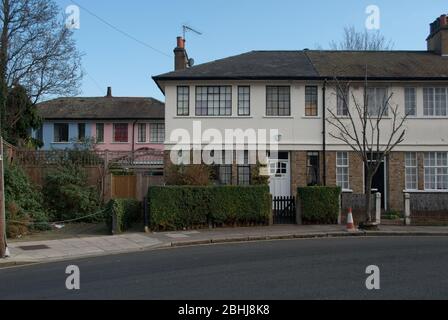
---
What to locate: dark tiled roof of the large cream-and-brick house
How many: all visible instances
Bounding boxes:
[153,50,448,86]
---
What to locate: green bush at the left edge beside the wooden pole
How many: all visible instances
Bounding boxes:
[4,162,49,238]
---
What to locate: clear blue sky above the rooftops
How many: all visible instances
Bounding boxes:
[56,0,448,101]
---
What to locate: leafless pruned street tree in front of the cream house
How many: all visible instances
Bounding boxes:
[327,76,408,224]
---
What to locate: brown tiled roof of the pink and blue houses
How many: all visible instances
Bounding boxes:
[38,97,165,120]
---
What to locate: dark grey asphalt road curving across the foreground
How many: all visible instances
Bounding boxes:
[0,238,448,300]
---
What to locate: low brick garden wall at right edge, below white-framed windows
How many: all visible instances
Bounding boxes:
[410,192,448,226]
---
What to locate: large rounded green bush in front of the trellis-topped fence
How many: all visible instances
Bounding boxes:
[43,162,101,222]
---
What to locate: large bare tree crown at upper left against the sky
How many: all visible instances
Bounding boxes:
[0,0,82,103]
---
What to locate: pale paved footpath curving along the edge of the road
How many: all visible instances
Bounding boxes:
[0,225,448,268]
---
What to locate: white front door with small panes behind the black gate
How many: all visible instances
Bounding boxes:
[269,152,291,198]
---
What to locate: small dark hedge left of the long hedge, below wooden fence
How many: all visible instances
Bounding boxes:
[106,199,143,234]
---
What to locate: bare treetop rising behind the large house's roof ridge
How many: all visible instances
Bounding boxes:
[330,26,394,51]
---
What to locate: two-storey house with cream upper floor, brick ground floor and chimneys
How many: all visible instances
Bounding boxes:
[153,15,448,210]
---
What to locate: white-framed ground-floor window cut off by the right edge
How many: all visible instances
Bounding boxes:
[425,152,448,190]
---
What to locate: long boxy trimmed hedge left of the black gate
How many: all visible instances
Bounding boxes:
[148,186,272,230]
